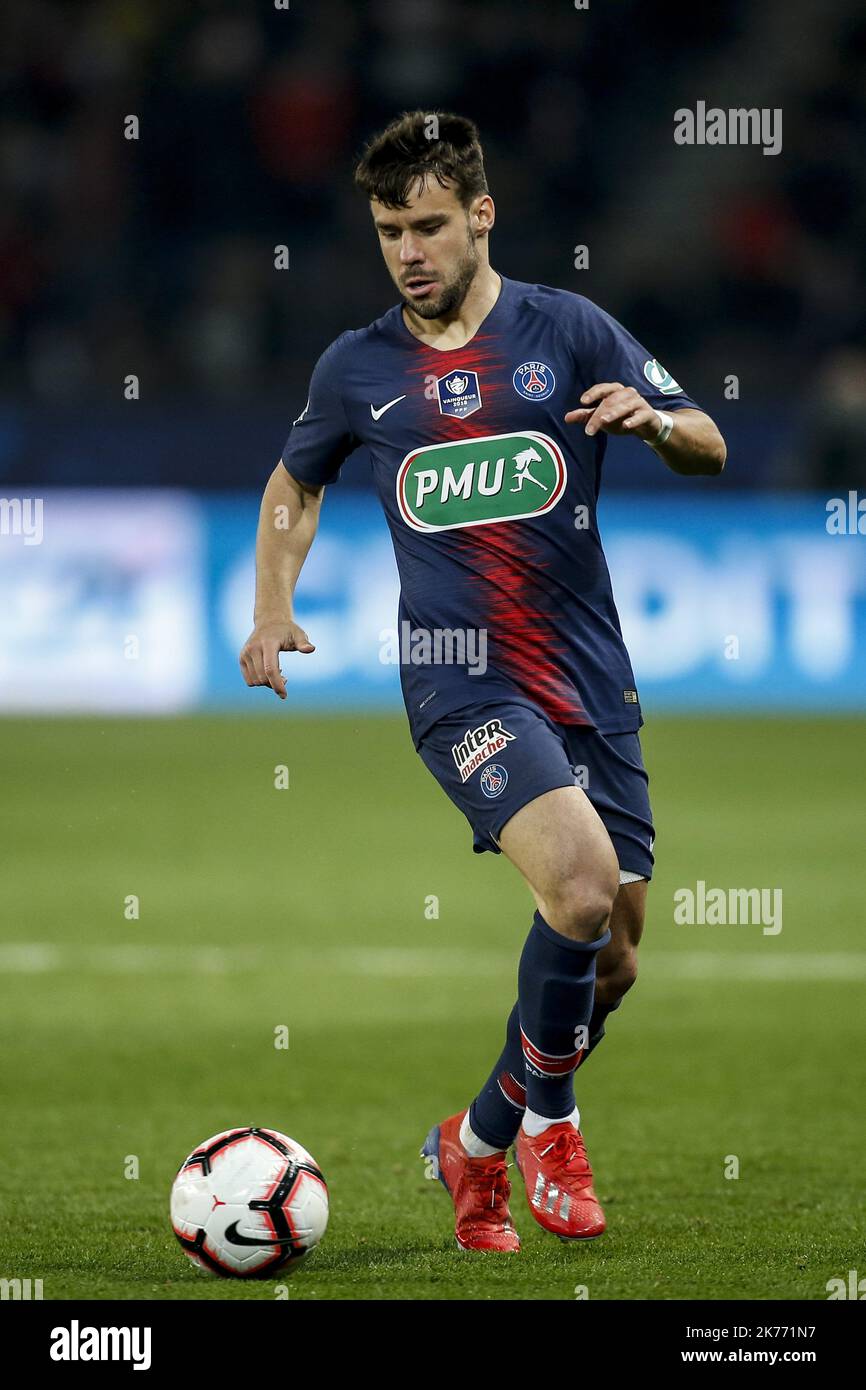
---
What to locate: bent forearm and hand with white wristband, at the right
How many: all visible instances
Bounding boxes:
[566,381,727,477]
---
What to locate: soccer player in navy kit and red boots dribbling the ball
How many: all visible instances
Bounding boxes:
[240,111,726,1251]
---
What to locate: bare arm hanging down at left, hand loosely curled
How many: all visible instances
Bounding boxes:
[240,461,325,699]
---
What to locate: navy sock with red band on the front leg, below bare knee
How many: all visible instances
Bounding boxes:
[522,912,610,1123]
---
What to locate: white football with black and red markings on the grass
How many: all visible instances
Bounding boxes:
[171,1129,328,1279]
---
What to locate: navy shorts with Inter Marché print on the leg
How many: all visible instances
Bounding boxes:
[418,701,653,878]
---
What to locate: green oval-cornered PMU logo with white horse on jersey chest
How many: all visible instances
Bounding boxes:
[396,430,567,531]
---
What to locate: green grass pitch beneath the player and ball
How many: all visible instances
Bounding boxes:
[0,708,866,1300]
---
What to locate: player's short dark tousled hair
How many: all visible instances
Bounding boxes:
[354,111,488,207]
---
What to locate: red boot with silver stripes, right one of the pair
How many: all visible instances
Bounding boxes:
[514,1120,605,1240]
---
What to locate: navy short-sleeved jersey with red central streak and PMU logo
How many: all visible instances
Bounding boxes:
[282,277,695,746]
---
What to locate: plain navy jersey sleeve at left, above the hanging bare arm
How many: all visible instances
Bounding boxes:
[282,335,360,488]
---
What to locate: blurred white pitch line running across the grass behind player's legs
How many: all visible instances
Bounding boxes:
[0,937,866,986]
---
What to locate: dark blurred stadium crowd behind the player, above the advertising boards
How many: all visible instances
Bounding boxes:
[0,0,866,487]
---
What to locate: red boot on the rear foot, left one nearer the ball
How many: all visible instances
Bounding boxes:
[421,1111,520,1252]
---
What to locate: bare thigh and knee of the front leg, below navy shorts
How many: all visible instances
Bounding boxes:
[499,785,619,940]
